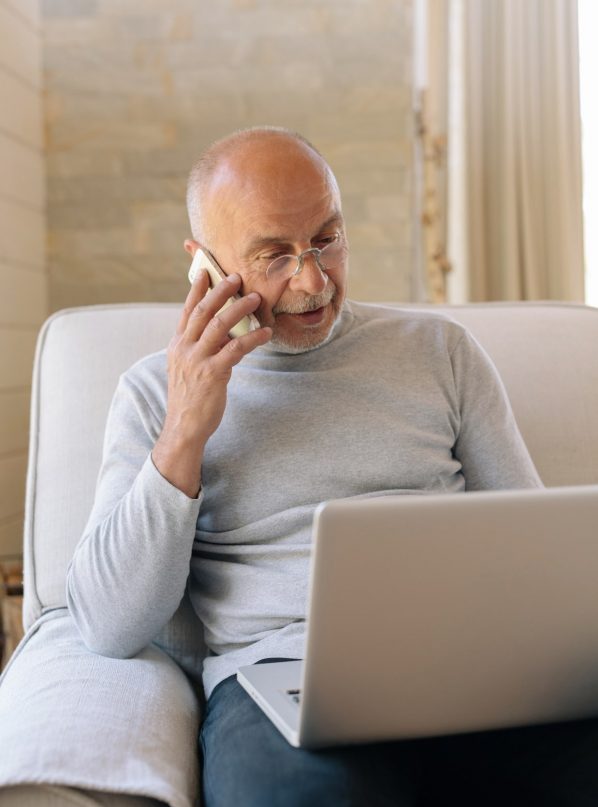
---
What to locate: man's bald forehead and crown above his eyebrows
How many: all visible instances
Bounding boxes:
[204,143,340,242]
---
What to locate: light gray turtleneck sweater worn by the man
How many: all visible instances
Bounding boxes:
[67,303,541,695]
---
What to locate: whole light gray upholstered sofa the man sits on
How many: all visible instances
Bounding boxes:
[0,303,598,807]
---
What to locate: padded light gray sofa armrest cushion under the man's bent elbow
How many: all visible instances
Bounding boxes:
[0,609,200,807]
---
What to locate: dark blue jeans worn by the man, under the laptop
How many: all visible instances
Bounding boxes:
[200,664,598,807]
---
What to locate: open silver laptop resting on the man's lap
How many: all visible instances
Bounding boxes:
[237,486,598,747]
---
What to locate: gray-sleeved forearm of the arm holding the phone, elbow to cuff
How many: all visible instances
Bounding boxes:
[67,457,199,658]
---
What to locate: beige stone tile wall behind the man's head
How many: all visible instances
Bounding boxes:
[42,0,412,310]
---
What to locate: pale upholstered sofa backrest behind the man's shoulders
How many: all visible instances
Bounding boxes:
[24,303,598,626]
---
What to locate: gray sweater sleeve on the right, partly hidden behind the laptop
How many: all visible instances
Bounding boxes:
[451,332,542,490]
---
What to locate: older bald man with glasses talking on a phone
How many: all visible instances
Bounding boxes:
[68,128,596,807]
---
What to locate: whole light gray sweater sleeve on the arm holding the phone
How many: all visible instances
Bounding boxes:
[67,374,201,658]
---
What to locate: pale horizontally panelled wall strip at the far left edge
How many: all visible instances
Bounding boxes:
[0,0,48,558]
